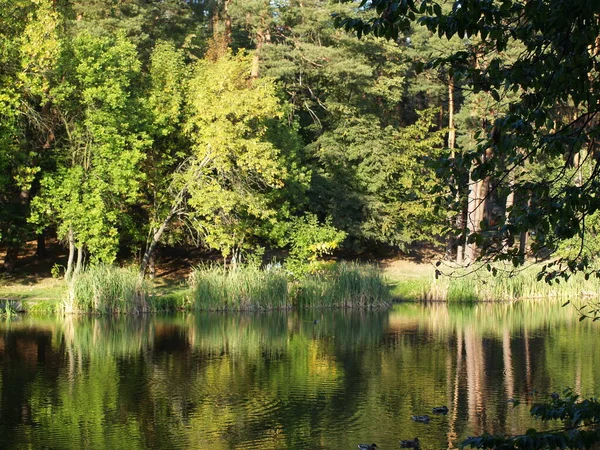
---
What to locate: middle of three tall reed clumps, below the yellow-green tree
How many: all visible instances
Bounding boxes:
[189,266,290,311]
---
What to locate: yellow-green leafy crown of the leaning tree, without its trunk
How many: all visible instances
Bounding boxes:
[182,52,287,256]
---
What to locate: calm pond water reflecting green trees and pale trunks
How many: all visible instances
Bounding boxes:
[0,304,600,450]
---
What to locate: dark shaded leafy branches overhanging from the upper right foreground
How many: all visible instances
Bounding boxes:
[337,0,600,280]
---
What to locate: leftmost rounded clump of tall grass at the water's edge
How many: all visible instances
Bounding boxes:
[62,265,151,313]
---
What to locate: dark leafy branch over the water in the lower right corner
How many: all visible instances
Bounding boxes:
[461,390,600,450]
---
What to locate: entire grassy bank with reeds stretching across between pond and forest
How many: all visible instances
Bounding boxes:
[0,260,600,315]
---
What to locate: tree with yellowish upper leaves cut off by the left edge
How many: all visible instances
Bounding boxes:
[0,0,60,270]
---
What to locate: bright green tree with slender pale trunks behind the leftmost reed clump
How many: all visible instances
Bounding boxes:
[31,31,149,273]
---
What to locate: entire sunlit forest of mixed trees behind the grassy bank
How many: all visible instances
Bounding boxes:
[0,0,600,279]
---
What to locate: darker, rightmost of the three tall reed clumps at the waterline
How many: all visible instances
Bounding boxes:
[294,262,391,308]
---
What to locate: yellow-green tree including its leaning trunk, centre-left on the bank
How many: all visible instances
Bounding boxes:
[140,48,306,276]
